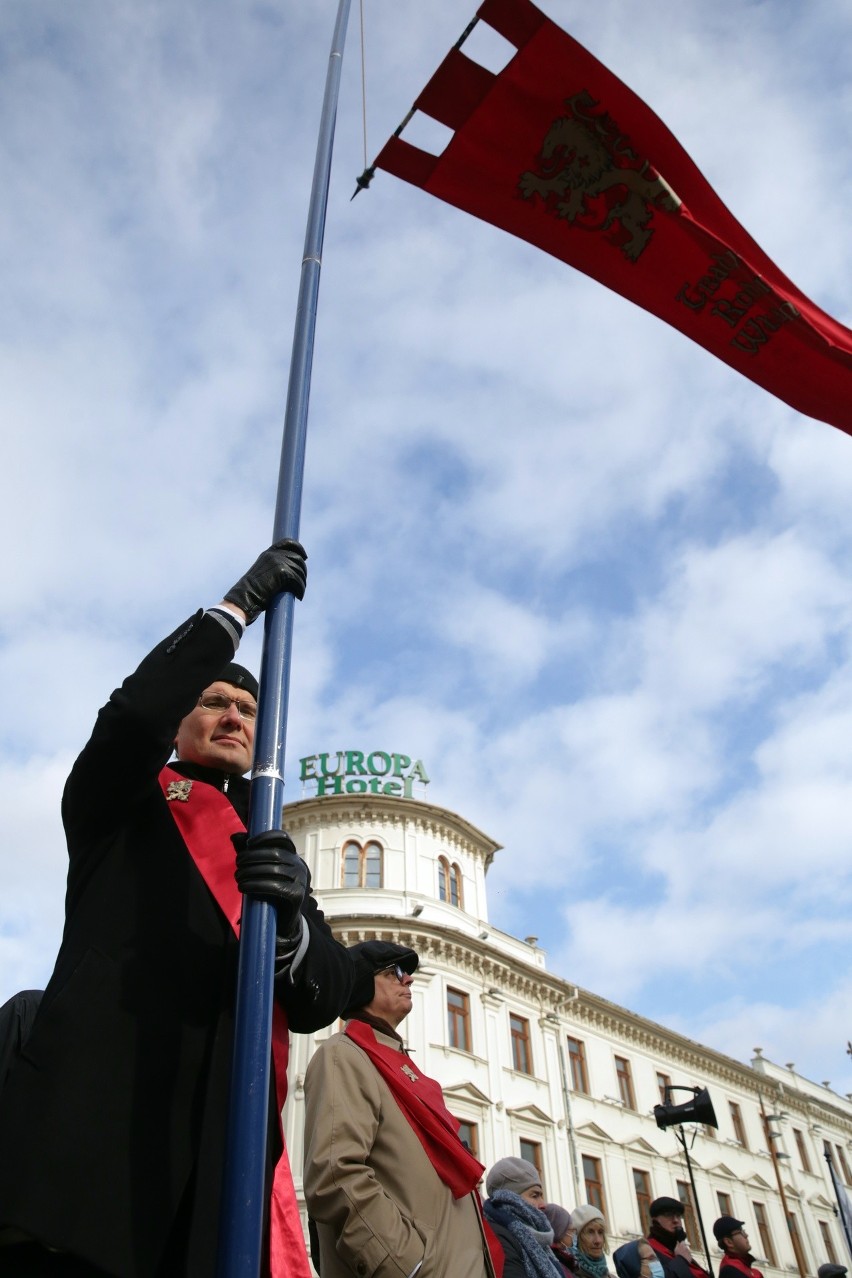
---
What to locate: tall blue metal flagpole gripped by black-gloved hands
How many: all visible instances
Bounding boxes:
[218,0,350,1278]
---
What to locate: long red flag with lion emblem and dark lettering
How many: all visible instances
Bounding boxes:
[376,0,852,433]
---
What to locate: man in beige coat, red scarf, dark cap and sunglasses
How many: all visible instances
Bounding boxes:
[304,941,496,1278]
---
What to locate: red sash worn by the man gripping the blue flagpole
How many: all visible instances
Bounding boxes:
[160,768,312,1278]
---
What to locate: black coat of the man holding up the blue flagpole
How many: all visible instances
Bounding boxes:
[0,612,351,1278]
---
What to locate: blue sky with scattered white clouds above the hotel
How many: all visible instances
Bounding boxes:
[0,0,852,1093]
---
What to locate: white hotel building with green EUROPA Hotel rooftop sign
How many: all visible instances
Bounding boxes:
[284,751,852,1278]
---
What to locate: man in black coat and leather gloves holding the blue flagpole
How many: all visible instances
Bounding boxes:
[0,541,353,1278]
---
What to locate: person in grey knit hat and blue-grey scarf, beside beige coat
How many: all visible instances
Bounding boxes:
[483,1158,565,1278]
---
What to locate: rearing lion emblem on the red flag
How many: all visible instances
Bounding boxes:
[517,89,681,262]
